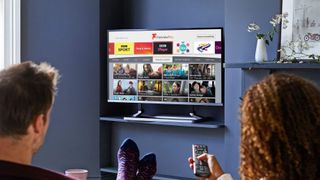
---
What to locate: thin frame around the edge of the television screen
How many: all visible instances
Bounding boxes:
[106,27,225,106]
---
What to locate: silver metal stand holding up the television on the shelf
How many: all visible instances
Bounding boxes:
[123,104,205,123]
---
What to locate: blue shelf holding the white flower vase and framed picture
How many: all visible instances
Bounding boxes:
[224,62,320,70]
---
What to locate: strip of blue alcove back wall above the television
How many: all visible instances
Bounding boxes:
[127,0,225,28]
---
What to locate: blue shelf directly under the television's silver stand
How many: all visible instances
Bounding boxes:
[100,117,224,129]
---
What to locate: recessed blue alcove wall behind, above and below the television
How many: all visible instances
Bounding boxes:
[101,0,225,178]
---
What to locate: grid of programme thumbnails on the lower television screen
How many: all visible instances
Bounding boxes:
[113,63,215,103]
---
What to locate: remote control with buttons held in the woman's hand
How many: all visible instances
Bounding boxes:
[192,144,210,177]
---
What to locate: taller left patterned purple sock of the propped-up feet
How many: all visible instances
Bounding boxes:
[117,138,139,180]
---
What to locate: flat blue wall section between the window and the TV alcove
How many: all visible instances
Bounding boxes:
[21,0,100,176]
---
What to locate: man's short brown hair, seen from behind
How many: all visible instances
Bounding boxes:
[0,61,60,136]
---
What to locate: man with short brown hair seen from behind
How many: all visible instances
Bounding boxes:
[0,62,71,180]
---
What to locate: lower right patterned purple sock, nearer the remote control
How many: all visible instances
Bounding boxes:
[137,153,157,180]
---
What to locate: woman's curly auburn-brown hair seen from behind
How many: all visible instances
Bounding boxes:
[240,73,320,180]
